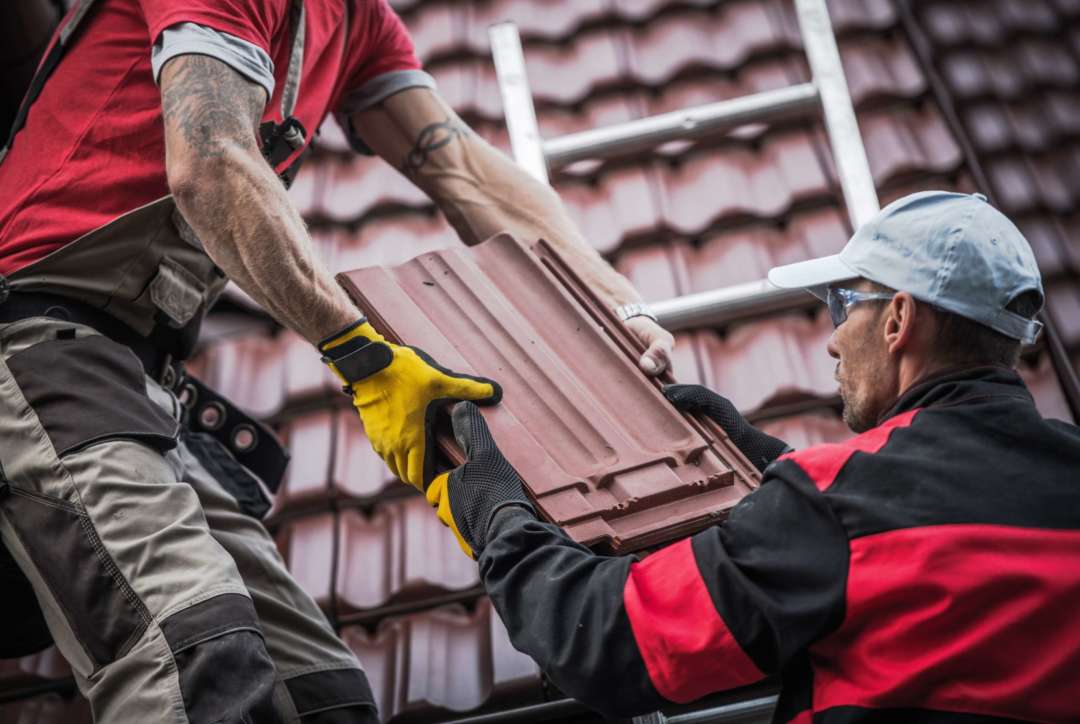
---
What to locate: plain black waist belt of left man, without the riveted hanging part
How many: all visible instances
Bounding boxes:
[0,292,179,388]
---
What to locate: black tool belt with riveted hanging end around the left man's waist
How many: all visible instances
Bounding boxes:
[0,289,289,499]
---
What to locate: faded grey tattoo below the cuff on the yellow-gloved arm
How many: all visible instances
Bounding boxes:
[161,55,266,159]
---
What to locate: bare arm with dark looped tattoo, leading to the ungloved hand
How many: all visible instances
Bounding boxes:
[352,88,640,306]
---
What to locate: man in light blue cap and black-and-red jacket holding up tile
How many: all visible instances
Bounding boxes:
[432,191,1080,724]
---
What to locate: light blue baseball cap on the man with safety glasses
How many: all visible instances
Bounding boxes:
[769,191,1045,344]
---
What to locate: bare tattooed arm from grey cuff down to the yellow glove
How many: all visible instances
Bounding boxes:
[161,55,360,343]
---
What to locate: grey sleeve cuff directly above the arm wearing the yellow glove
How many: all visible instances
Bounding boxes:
[150,23,274,99]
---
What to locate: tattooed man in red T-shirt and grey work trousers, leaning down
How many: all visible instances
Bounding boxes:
[0,0,672,724]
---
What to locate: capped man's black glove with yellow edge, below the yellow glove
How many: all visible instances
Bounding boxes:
[424,402,536,559]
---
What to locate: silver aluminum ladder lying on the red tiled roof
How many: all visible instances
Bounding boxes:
[488,0,880,331]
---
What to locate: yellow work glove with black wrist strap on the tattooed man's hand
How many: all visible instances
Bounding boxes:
[319,317,502,493]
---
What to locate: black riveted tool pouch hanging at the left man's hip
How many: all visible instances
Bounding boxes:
[177,375,289,519]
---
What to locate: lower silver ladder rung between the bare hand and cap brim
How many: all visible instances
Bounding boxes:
[649,279,813,332]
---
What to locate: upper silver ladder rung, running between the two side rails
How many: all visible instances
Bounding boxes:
[543,83,821,167]
